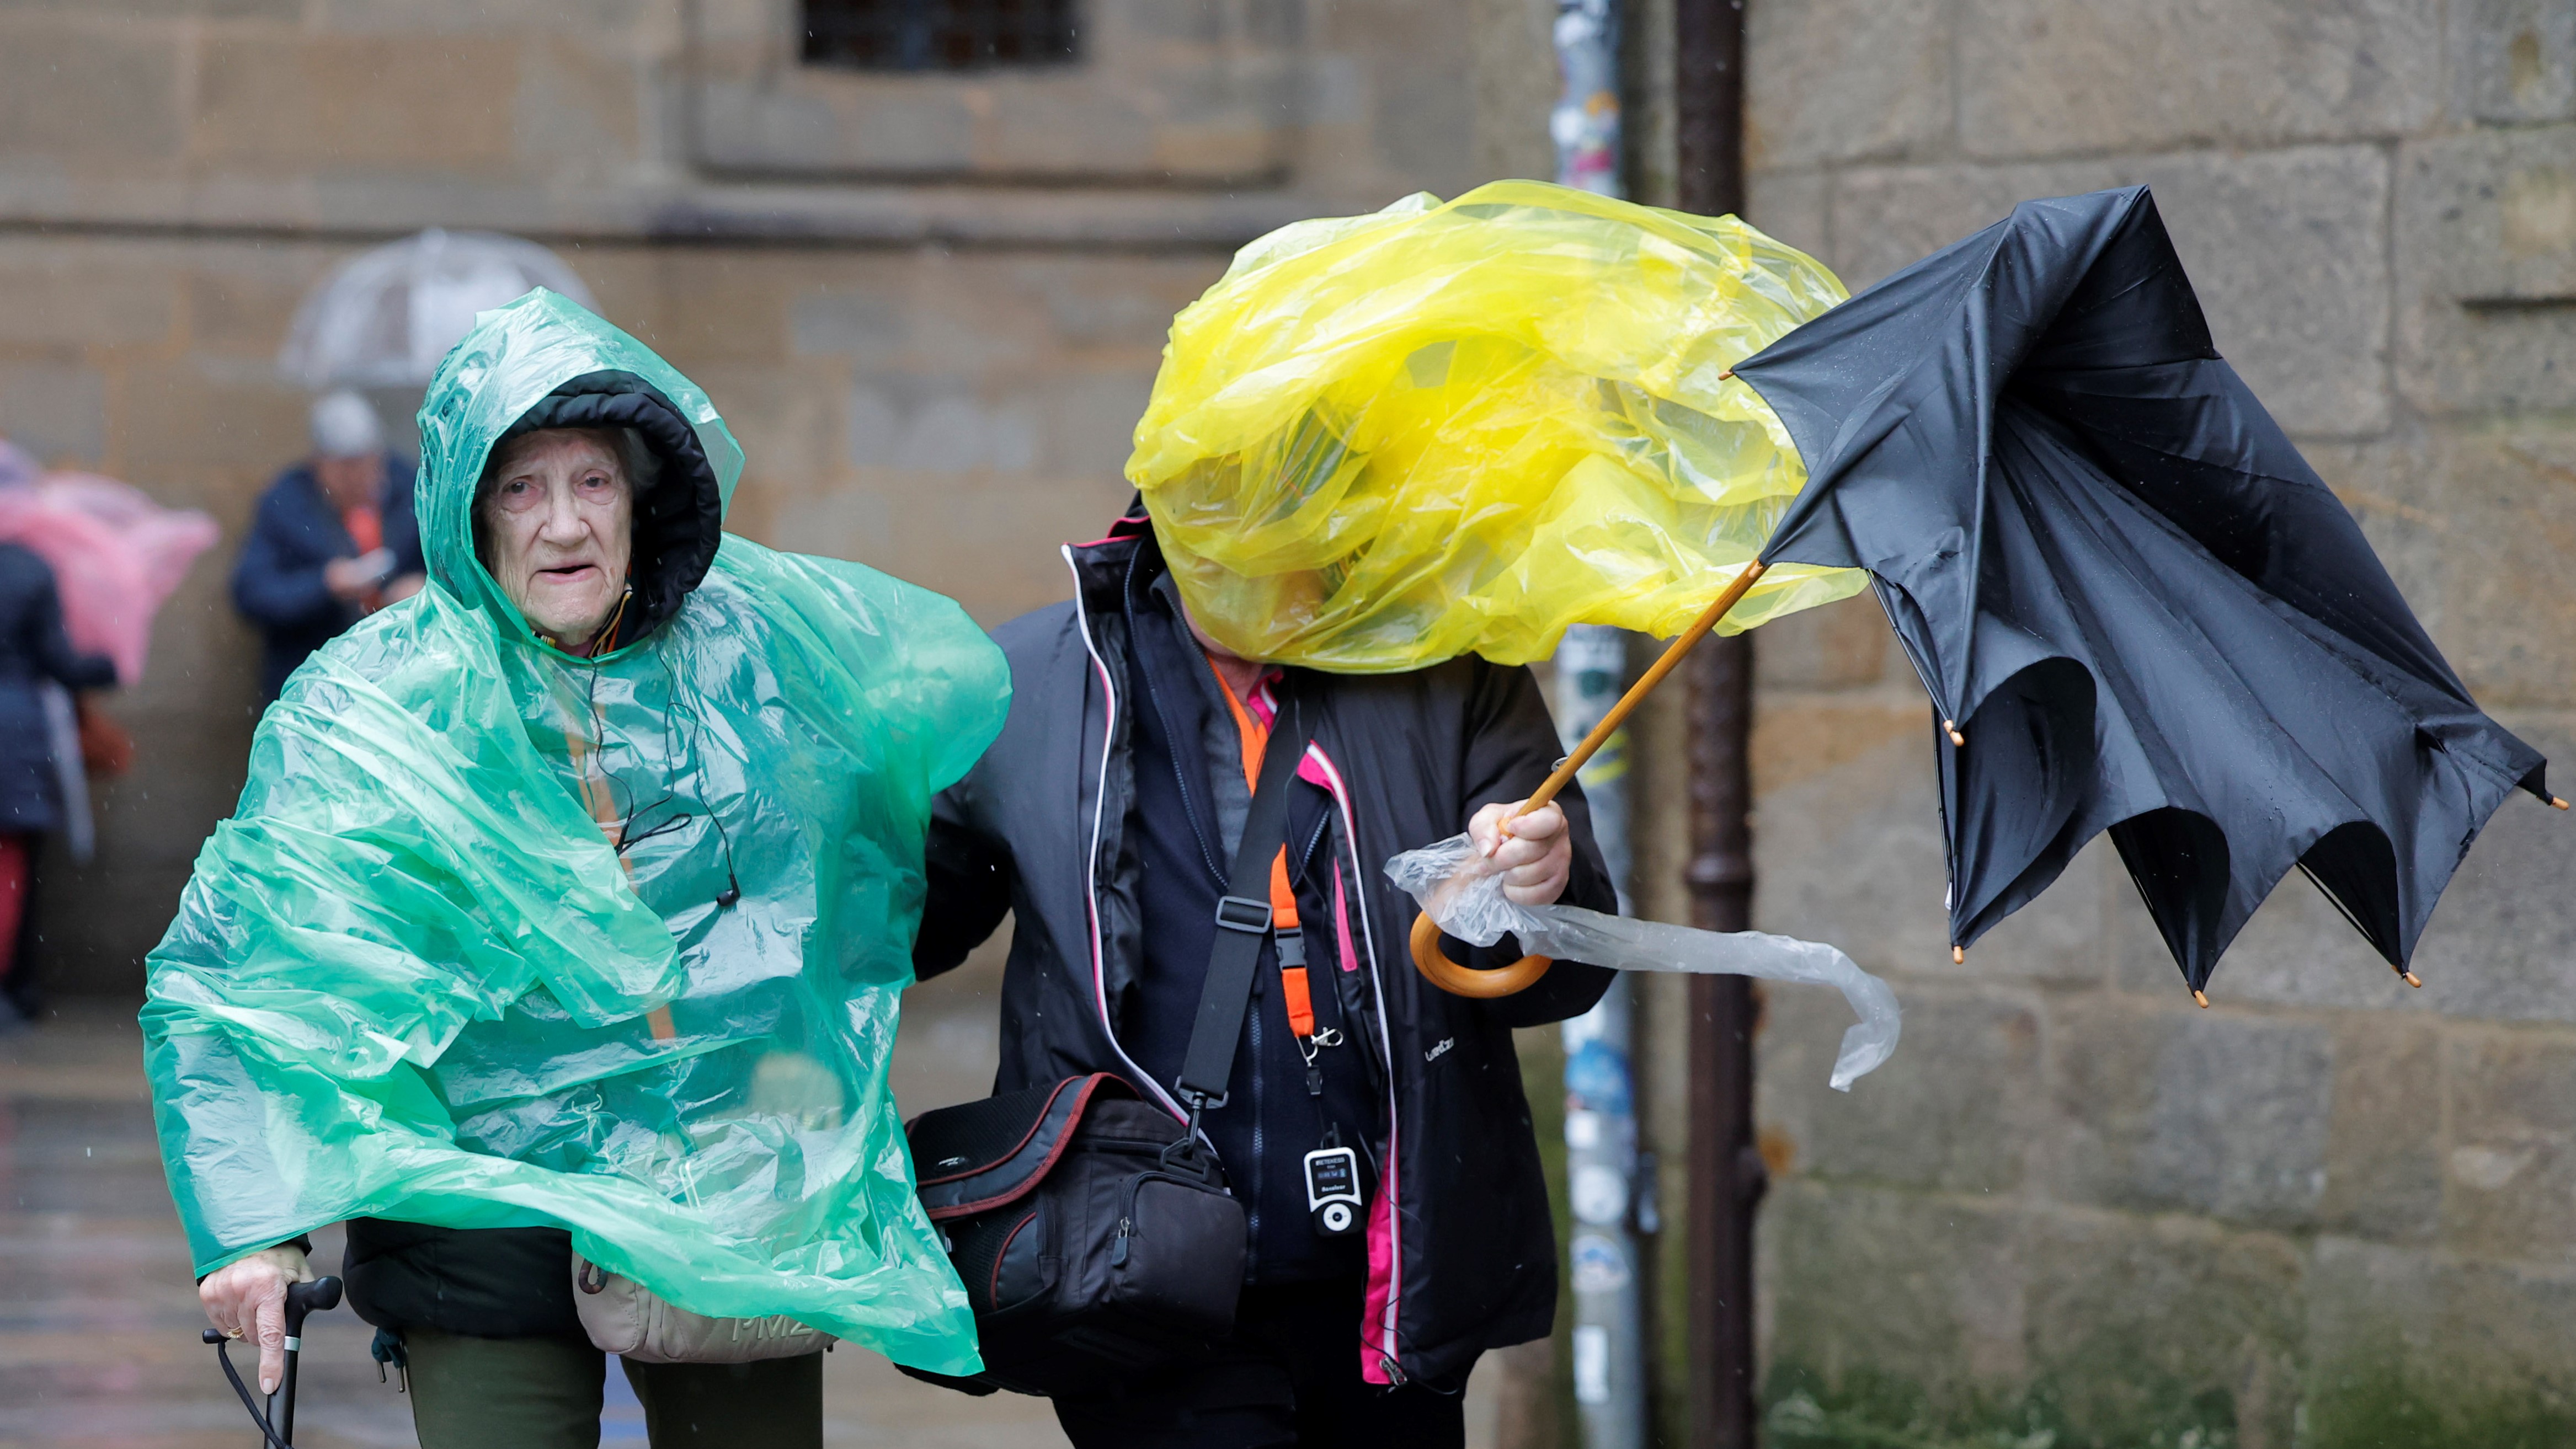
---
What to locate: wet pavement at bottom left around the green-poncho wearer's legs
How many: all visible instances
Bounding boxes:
[0,970,1064,1449]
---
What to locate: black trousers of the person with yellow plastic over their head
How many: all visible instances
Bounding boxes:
[1056,1279,1466,1449]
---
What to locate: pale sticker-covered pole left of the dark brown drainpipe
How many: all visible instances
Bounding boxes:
[1548,0,1654,1449]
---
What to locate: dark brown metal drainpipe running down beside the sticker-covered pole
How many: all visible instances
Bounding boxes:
[1672,0,1770,1449]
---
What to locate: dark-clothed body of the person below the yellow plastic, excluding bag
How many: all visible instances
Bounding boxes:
[914,491,1615,1449]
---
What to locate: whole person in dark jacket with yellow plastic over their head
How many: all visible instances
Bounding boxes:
[917,183,1863,1449]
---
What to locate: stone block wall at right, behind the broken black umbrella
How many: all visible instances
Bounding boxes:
[1747,0,2576,1449]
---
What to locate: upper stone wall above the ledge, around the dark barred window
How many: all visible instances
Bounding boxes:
[0,0,1481,250]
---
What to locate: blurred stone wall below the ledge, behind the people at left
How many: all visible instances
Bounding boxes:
[0,234,1224,993]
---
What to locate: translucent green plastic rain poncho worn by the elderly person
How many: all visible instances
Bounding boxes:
[144,291,1010,1375]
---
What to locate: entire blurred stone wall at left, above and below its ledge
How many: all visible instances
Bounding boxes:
[0,0,1494,993]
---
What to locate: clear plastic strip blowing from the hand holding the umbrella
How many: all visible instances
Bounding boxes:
[1386,834,1898,1091]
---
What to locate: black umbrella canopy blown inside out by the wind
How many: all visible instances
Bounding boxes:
[1736,185,2550,993]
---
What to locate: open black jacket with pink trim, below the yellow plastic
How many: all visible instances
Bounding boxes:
[914,522,1615,1390]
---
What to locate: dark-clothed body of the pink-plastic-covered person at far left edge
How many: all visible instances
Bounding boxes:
[0,543,116,1029]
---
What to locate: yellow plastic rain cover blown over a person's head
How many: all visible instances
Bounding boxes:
[1128,180,1865,675]
